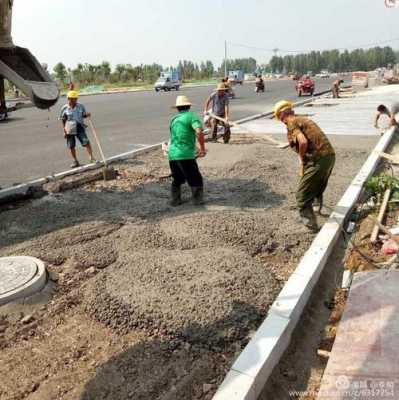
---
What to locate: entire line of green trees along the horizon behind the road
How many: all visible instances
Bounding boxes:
[54,47,399,85]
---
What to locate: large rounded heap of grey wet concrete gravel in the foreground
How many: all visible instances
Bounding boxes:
[86,247,279,346]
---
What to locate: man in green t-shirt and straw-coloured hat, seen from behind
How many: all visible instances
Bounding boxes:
[168,96,206,207]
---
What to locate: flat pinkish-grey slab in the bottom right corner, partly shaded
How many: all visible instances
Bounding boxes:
[318,271,399,400]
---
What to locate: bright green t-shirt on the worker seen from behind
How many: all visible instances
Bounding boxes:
[168,111,202,161]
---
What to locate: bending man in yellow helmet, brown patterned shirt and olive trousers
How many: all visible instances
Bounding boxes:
[274,100,335,231]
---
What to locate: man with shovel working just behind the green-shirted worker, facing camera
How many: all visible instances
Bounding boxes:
[204,83,231,143]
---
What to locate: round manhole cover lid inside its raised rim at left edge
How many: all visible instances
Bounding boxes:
[0,257,38,296]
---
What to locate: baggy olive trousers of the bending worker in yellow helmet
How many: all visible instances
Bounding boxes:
[296,154,335,210]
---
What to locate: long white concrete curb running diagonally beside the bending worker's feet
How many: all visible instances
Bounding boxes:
[213,128,395,400]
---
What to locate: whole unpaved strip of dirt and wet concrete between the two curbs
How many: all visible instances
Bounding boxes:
[0,136,378,400]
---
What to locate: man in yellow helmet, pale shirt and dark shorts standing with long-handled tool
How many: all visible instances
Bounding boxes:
[60,90,96,168]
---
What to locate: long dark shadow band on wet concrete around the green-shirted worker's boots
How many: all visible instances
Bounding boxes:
[0,178,285,247]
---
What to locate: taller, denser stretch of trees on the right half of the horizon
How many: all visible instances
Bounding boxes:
[266,47,399,74]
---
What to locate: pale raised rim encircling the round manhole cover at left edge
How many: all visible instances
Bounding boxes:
[0,256,47,306]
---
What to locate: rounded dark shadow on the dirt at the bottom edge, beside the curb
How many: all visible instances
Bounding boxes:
[80,302,264,400]
